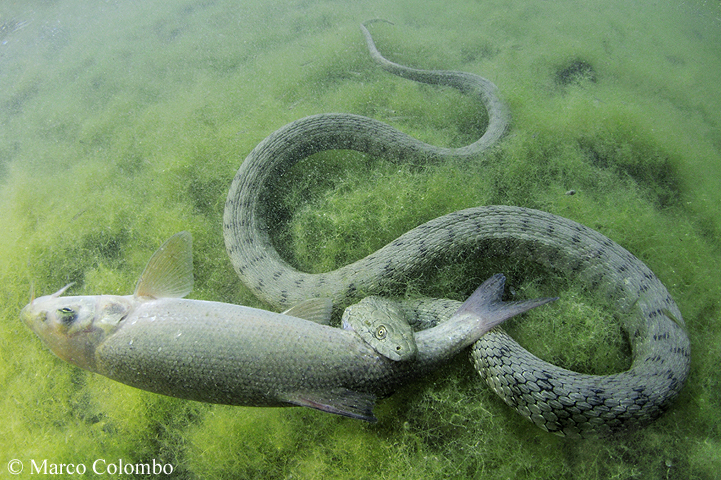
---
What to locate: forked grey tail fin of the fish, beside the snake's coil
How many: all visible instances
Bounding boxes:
[453,273,558,338]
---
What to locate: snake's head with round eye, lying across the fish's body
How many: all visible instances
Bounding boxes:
[342,297,418,361]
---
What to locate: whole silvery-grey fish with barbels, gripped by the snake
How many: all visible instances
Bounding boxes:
[20,232,554,422]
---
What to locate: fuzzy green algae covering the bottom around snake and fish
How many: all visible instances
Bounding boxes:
[0,0,721,479]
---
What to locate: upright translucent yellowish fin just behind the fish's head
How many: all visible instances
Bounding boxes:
[135,232,193,298]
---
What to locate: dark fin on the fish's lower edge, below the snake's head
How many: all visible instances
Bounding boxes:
[286,388,378,423]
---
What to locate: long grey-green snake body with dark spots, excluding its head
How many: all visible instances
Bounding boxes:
[223,22,690,438]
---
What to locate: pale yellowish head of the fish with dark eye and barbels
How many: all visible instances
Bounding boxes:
[20,285,133,371]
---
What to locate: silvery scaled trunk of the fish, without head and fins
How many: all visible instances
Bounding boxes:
[96,299,404,406]
